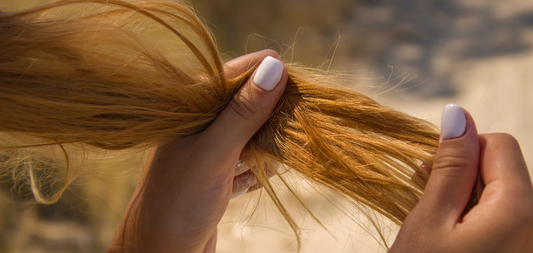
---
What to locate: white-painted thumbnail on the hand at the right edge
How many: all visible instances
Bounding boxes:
[440,104,466,140]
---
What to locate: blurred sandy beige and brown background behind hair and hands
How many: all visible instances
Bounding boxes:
[0,0,533,253]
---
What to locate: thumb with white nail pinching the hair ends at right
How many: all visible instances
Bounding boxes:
[416,104,480,223]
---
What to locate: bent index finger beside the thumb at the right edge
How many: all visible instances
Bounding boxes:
[456,133,533,247]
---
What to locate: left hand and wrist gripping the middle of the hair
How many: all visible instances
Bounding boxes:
[107,50,288,252]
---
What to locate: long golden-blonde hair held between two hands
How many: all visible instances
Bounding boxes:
[0,0,439,249]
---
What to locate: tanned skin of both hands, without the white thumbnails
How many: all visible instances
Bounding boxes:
[106,50,533,253]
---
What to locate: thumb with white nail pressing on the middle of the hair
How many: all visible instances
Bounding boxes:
[204,51,288,155]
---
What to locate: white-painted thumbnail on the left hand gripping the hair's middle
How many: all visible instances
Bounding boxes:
[253,56,283,91]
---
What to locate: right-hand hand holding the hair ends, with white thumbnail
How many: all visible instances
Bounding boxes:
[389,105,533,253]
